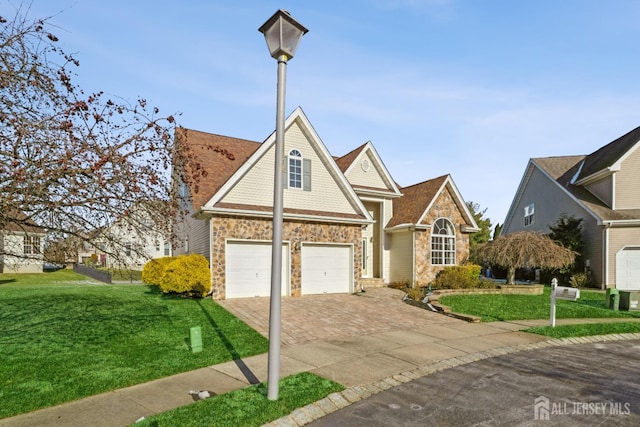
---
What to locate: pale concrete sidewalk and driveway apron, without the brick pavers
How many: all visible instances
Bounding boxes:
[5,290,640,427]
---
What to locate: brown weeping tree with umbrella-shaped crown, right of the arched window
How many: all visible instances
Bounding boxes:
[482,231,575,285]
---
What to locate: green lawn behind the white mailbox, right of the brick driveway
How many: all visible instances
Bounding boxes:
[440,287,640,322]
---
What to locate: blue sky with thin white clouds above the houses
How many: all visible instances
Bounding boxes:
[13,0,640,229]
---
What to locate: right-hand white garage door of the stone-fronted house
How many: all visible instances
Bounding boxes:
[302,244,353,295]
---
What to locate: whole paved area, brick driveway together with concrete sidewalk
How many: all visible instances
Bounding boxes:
[0,288,637,427]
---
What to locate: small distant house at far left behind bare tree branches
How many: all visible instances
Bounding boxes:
[0,214,45,273]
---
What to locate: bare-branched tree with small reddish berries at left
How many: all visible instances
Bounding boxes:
[0,7,175,264]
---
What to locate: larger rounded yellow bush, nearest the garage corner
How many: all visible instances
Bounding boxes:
[158,254,211,297]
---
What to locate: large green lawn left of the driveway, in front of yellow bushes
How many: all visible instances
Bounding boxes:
[0,270,268,418]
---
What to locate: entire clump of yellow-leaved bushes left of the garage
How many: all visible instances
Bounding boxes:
[142,254,211,297]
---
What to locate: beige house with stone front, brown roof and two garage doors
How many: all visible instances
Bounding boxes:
[174,108,478,299]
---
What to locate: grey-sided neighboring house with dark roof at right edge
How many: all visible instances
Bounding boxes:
[502,127,640,289]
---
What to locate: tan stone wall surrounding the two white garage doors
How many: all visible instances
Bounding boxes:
[210,217,362,299]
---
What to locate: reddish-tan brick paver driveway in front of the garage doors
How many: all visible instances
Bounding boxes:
[219,288,463,345]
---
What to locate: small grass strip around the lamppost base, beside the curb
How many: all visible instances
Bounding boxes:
[135,372,344,427]
